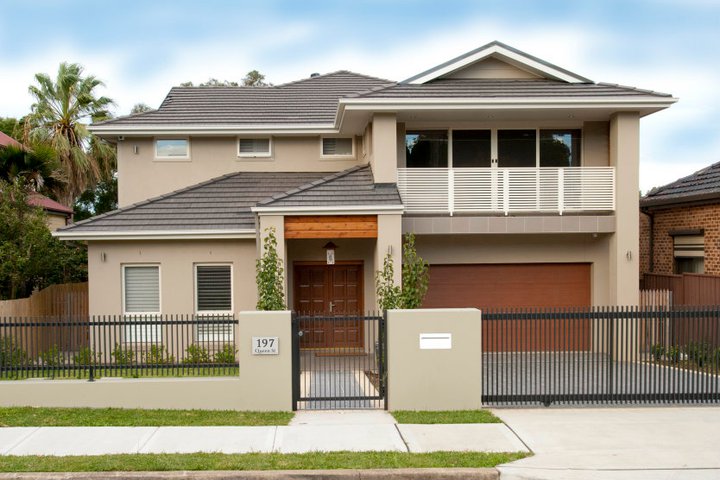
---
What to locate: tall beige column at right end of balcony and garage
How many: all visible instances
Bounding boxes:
[609,112,640,305]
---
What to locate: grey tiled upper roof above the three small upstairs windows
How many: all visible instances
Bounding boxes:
[95,70,393,126]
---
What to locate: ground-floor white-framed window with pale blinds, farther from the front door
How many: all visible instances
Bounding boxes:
[122,264,161,343]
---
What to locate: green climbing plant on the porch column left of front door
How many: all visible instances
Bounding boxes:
[255,227,285,310]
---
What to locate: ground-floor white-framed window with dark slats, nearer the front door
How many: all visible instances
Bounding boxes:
[195,263,234,341]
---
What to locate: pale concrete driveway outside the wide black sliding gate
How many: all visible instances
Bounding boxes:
[493,406,720,480]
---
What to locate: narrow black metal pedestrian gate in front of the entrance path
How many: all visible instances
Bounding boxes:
[292,313,387,410]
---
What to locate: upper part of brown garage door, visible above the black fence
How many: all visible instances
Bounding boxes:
[423,263,590,309]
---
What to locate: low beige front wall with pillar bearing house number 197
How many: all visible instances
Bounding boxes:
[0,312,292,411]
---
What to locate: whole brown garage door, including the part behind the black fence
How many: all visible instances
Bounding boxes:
[423,263,591,352]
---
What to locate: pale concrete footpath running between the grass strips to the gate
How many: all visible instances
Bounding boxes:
[0,411,527,456]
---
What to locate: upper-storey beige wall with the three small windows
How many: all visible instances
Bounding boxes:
[118,136,366,207]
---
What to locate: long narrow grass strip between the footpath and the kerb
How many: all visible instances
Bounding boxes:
[0,452,528,472]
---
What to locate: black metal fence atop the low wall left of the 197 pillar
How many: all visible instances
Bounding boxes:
[0,315,238,380]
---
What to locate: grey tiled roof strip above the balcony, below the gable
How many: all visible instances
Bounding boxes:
[346,79,672,99]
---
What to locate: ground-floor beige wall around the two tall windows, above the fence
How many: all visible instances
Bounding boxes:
[88,240,257,315]
